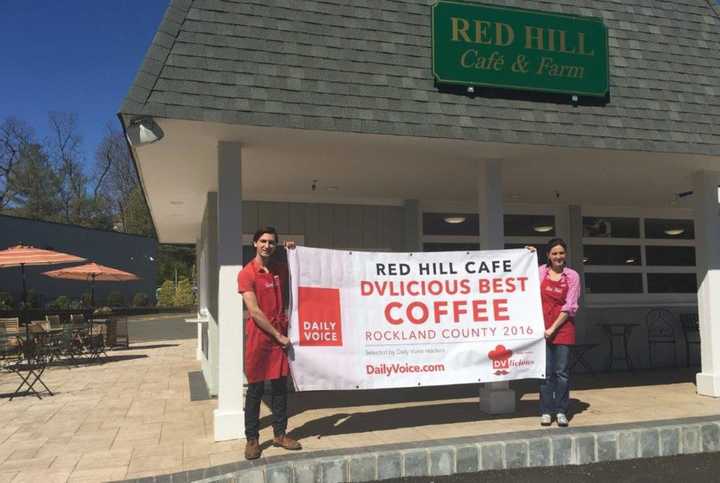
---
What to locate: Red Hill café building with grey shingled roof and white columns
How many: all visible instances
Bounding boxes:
[120,0,720,439]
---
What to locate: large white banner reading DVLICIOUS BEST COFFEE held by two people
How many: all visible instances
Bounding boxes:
[288,247,545,390]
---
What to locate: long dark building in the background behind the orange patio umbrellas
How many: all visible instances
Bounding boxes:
[0,215,157,305]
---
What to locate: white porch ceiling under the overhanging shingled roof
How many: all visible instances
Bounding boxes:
[129,119,720,243]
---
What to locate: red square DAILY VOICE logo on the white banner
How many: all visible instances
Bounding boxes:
[298,287,342,346]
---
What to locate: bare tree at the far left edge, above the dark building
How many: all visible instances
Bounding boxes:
[0,117,32,210]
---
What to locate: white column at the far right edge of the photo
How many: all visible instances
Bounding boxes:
[693,171,720,397]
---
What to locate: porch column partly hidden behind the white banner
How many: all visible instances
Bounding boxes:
[478,159,515,414]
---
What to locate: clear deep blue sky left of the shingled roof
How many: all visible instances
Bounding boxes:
[0,0,169,165]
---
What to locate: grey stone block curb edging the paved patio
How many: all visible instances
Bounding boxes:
[118,416,720,483]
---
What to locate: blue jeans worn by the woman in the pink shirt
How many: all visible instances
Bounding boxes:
[540,343,570,414]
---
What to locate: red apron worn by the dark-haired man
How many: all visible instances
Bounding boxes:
[245,261,289,383]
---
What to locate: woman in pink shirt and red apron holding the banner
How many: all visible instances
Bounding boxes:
[528,238,580,426]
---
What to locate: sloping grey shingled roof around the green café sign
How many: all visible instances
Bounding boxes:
[121,0,720,155]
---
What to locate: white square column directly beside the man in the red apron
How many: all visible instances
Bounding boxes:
[214,142,245,441]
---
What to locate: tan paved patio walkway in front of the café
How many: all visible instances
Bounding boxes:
[0,320,720,483]
